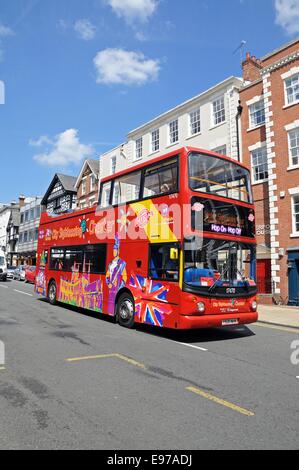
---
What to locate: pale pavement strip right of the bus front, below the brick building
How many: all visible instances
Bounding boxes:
[258,305,299,329]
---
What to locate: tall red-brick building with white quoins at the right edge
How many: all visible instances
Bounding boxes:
[240,38,299,306]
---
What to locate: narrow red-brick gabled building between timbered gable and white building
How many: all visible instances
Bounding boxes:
[75,160,99,209]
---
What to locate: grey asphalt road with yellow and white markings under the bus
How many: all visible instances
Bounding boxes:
[0,281,299,450]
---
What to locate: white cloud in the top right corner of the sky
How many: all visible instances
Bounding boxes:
[275,0,299,34]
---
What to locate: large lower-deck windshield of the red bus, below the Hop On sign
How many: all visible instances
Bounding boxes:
[184,238,256,296]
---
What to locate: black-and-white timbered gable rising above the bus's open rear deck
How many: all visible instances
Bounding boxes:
[41,173,77,214]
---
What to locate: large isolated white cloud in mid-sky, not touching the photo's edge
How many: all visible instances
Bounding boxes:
[94,49,160,85]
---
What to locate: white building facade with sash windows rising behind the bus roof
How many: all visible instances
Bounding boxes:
[100,77,243,178]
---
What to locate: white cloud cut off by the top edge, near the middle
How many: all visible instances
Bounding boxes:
[106,0,158,23]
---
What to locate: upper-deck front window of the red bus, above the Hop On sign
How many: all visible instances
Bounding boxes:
[189,152,252,203]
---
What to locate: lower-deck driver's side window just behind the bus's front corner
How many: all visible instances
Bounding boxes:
[149,243,179,281]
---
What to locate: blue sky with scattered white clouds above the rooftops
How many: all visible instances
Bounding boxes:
[0,0,299,203]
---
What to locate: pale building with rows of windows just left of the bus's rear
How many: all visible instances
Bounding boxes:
[18,197,42,266]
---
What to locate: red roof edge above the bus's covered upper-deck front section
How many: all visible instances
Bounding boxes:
[101,147,249,183]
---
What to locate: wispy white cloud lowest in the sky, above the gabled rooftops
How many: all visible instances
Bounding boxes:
[31,129,94,167]
